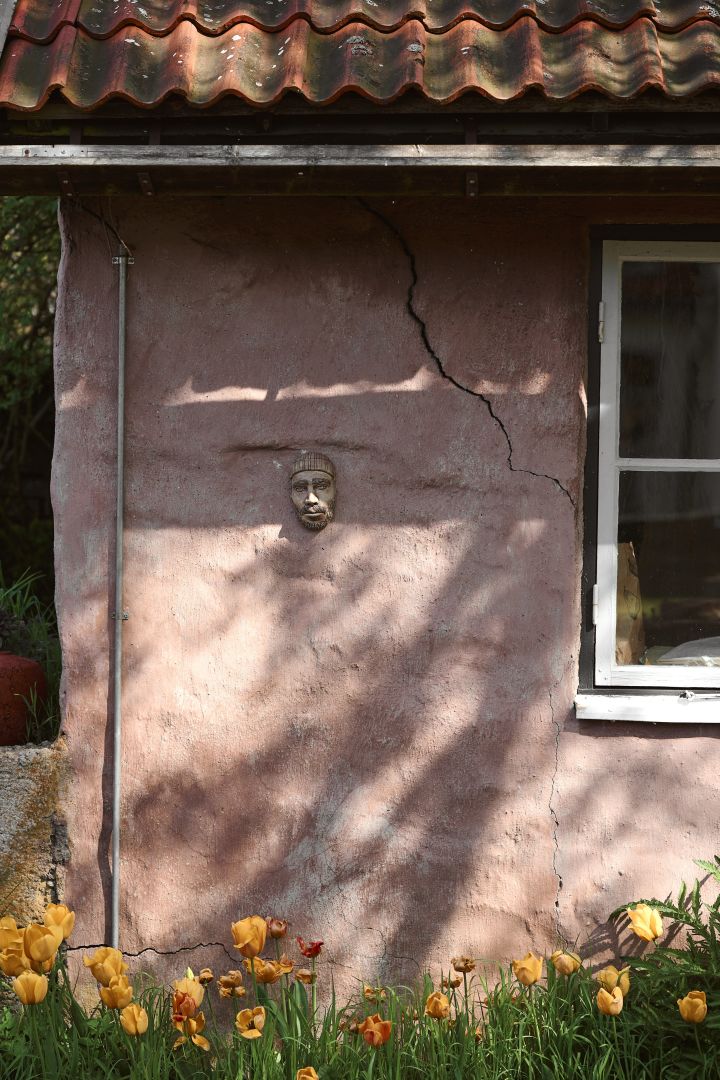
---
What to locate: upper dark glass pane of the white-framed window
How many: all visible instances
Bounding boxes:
[620,262,720,458]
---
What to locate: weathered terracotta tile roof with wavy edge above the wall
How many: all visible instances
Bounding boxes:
[0,0,720,110]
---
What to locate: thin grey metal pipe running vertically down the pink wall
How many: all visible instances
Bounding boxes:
[110,254,134,948]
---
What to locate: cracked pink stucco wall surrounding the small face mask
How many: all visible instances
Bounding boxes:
[53,198,718,977]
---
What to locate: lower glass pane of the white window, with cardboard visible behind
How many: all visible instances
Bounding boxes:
[615,472,720,669]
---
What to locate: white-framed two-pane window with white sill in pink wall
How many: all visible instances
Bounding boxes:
[576,240,720,721]
